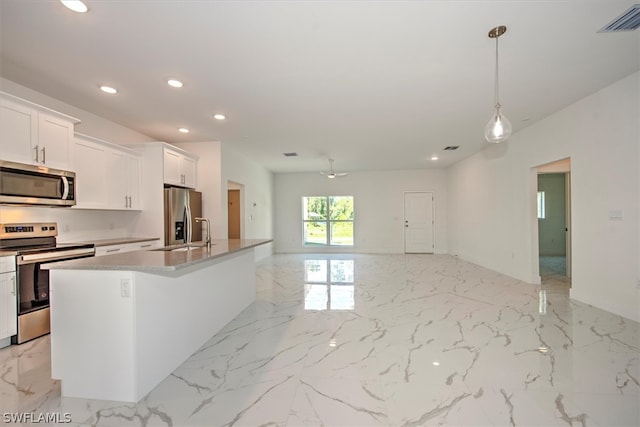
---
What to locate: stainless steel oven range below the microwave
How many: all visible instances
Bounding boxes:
[0,222,95,344]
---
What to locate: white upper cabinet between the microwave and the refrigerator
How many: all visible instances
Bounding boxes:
[73,134,142,210]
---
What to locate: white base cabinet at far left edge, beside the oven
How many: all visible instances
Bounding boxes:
[0,256,18,347]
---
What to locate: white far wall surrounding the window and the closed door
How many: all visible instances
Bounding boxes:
[275,169,447,253]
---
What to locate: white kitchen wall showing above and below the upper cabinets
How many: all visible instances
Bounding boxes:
[0,78,160,242]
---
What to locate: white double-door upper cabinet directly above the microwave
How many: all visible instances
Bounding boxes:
[0,92,80,170]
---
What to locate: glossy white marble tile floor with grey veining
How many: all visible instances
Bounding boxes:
[0,255,640,427]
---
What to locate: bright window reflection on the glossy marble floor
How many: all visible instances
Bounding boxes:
[304,259,355,310]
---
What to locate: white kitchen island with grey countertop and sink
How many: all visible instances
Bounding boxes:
[47,240,271,402]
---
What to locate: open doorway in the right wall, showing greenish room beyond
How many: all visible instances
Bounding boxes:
[537,159,571,287]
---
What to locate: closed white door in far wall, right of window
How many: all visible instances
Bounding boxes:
[404,192,435,253]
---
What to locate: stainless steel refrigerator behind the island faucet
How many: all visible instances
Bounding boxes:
[164,187,202,246]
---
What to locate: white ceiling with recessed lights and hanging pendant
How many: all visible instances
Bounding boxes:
[0,0,640,172]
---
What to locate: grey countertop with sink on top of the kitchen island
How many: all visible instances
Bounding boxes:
[42,239,273,274]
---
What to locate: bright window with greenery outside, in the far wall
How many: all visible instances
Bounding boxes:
[302,196,354,246]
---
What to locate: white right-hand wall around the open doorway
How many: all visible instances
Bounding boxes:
[447,73,640,321]
